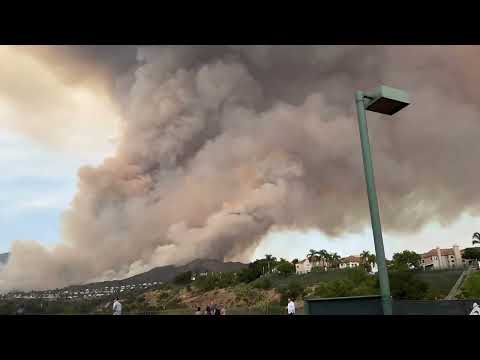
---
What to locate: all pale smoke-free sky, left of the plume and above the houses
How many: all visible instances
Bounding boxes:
[0,46,480,259]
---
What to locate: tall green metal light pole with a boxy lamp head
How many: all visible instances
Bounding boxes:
[355,86,410,315]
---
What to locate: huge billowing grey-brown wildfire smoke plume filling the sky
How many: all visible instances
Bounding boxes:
[0,46,480,288]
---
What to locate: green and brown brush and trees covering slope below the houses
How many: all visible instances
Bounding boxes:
[0,249,466,314]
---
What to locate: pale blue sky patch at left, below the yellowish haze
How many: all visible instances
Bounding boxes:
[0,129,109,253]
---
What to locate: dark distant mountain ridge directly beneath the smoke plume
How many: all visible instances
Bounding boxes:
[70,260,248,288]
